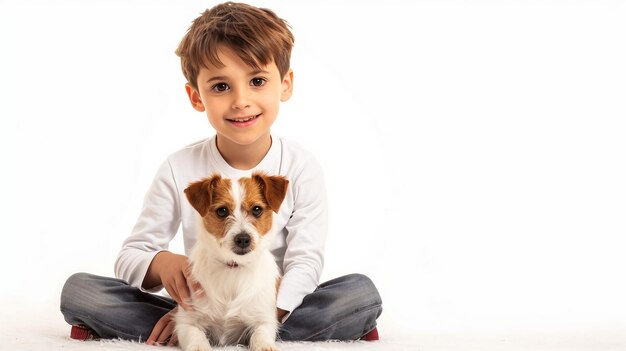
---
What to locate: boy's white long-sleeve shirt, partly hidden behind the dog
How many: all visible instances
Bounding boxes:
[115,136,328,312]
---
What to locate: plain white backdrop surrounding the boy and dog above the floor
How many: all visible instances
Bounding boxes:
[0,0,626,338]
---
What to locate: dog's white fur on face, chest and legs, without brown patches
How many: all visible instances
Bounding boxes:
[175,176,287,351]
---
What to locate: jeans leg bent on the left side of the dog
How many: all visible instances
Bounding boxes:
[61,273,176,341]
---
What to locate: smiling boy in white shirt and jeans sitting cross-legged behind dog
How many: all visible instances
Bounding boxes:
[61,2,382,344]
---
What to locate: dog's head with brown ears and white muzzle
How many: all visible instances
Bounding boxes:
[185,173,289,265]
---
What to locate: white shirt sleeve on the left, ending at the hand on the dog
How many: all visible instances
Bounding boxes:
[115,161,180,292]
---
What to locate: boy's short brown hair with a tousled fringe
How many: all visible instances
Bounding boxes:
[176,2,294,90]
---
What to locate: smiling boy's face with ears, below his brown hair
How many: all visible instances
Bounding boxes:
[186,48,293,152]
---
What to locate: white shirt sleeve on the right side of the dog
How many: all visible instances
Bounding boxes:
[277,160,328,321]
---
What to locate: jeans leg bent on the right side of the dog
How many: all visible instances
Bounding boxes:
[279,274,382,341]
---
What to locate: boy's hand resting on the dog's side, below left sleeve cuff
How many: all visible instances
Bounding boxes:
[143,251,201,310]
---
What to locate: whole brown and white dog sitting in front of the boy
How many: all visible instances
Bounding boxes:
[175,173,289,351]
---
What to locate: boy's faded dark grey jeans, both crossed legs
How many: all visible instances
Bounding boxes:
[61,273,382,341]
